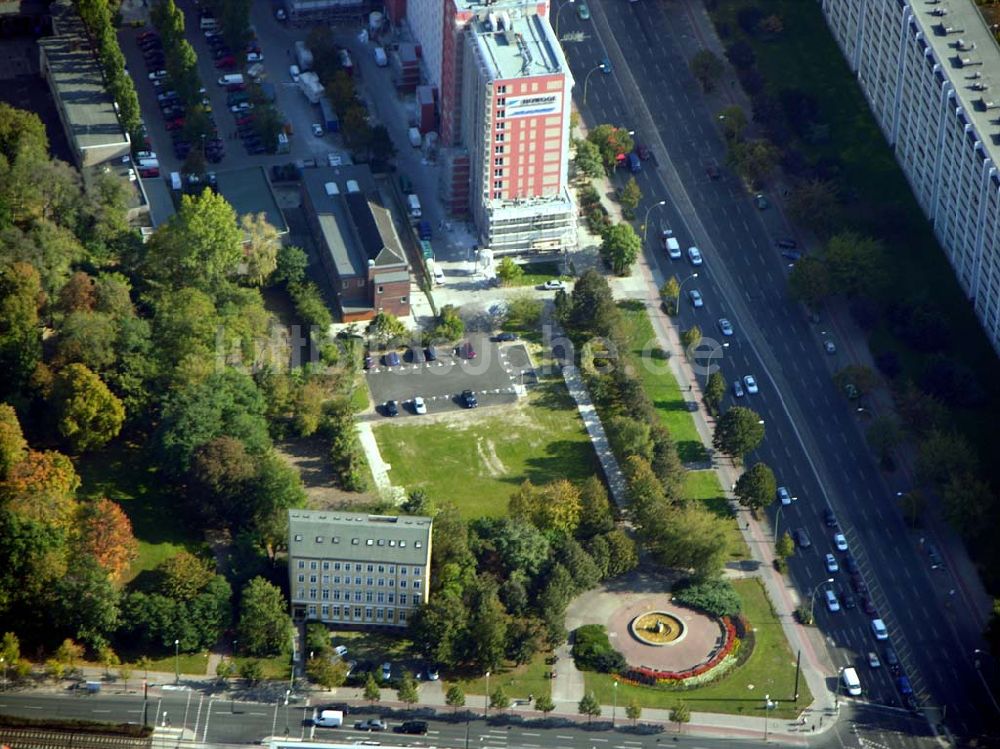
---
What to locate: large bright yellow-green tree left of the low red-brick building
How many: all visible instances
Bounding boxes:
[144,190,243,294]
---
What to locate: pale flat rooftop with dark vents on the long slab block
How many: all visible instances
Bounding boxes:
[911,0,1000,153]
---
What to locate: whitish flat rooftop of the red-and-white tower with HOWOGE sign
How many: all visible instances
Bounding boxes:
[470,6,567,79]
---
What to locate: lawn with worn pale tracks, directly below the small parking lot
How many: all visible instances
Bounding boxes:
[374,380,600,518]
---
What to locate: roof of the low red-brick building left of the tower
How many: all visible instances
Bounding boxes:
[302,165,406,278]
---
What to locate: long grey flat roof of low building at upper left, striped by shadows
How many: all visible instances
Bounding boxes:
[38,2,128,151]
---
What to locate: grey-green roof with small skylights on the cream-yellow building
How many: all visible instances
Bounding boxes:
[288,510,434,564]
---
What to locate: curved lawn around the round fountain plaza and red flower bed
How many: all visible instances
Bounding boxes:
[584,579,812,718]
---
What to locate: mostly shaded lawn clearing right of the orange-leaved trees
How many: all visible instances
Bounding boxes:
[76,444,204,580]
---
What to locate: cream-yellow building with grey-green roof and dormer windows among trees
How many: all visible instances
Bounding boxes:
[288,510,433,627]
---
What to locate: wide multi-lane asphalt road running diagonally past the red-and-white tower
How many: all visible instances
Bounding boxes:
[560,0,996,734]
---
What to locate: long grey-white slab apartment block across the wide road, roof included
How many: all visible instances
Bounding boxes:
[820,0,1000,351]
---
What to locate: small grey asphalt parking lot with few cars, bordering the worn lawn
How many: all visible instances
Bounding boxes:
[367,336,534,417]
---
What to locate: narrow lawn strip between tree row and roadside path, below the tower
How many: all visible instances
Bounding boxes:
[618,302,708,463]
